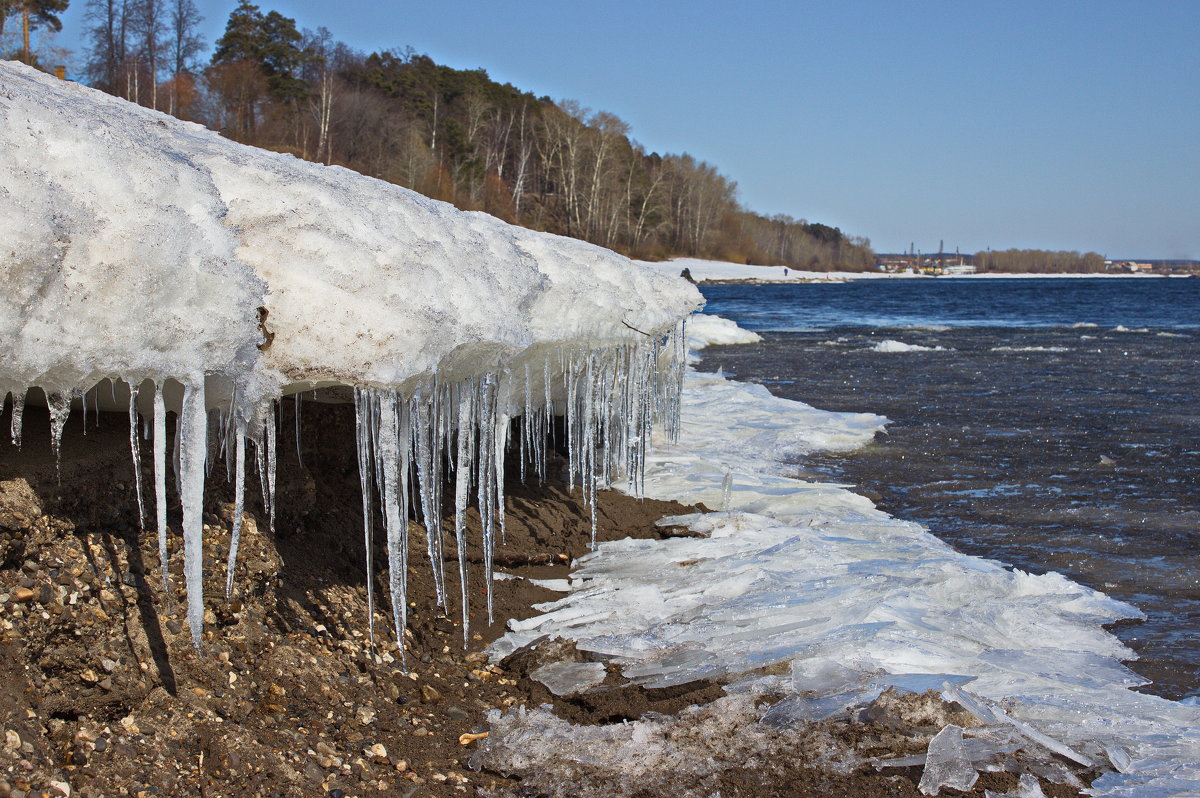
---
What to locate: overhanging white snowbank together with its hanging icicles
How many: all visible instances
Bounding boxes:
[0,62,703,646]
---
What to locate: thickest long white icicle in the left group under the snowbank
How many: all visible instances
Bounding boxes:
[175,377,209,650]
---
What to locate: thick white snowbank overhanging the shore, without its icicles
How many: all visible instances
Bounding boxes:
[0,62,701,394]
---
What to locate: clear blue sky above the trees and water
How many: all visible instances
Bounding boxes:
[49,0,1200,258]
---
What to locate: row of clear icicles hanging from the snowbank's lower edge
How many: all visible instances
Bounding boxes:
[4,323,686,658]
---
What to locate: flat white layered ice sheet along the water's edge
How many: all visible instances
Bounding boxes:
[494,314,1200,796]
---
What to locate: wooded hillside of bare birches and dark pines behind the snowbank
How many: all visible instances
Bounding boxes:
[7,0,875,270]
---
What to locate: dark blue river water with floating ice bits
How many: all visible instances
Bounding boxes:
[701,278,1200,698]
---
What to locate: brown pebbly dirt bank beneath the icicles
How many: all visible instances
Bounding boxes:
[0,402,1094,798]
